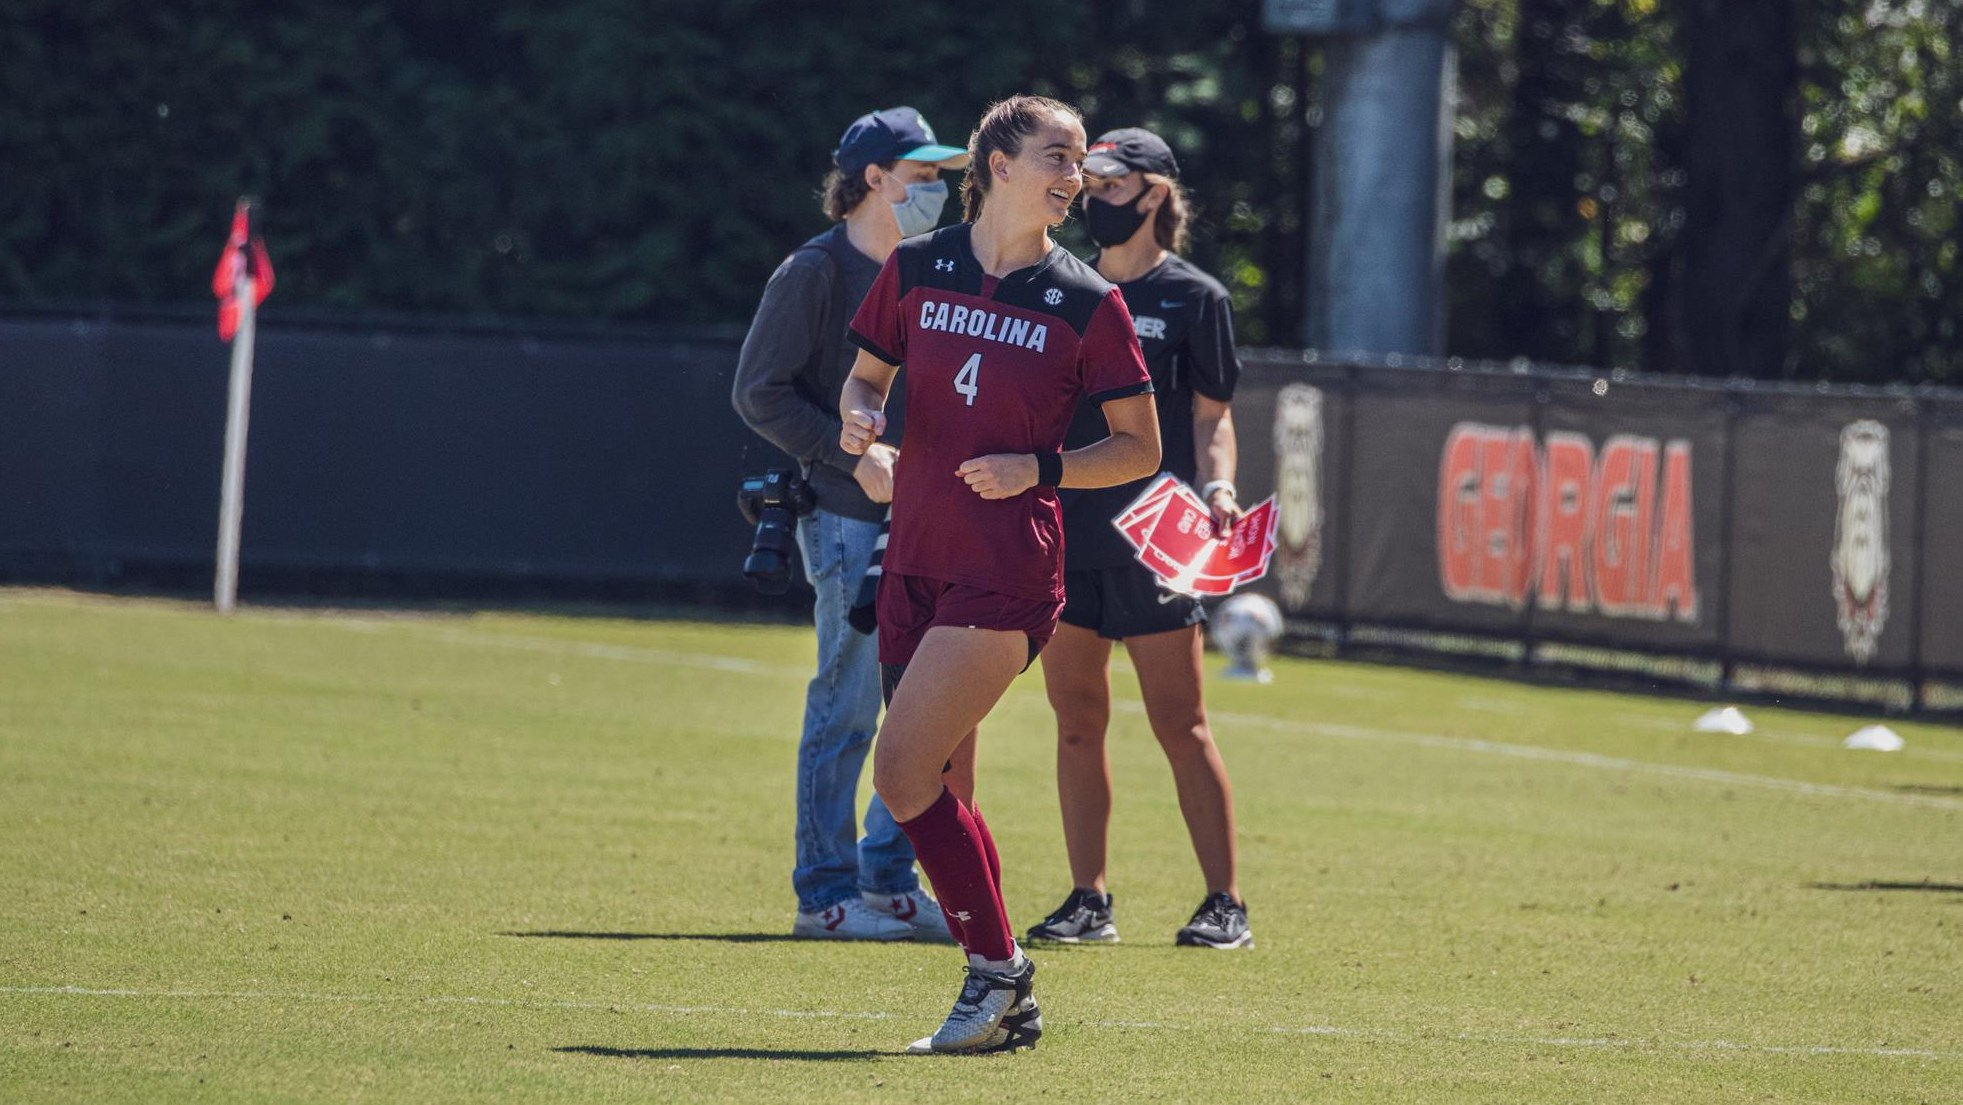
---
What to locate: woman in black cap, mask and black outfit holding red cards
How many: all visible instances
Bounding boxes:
[1027,128,1254,948]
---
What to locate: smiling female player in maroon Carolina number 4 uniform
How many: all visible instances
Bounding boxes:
[838,96,1158,1052]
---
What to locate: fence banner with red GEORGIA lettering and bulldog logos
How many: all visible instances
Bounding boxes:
[1235,351,1963,707]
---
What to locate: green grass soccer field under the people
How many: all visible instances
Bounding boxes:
[0,591,1963,1103]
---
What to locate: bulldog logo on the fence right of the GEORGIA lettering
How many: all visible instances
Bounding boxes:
[1831,418,1888,663]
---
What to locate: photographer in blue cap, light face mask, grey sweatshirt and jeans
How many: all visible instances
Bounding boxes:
[732,108,968,940]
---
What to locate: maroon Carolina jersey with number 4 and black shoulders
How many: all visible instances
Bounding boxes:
[852,224,1152,603]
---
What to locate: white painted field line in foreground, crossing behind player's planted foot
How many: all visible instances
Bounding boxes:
[0,985,1963,1060]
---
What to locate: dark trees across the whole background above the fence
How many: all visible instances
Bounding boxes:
[0,0,1963,381]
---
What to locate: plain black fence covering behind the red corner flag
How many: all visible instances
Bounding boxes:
[0,320,761,597]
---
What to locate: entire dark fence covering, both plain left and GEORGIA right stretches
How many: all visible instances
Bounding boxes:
[0,314,1963,709]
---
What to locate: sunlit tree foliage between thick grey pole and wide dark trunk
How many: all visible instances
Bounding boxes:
[1449,0,1684,371]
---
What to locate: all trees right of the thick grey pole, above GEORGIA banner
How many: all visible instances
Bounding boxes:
[1449,0,1963,383]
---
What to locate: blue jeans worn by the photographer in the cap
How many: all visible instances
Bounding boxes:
[791,510,921,913]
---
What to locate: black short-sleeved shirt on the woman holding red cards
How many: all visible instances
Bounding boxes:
[1058,253,1241,571]
